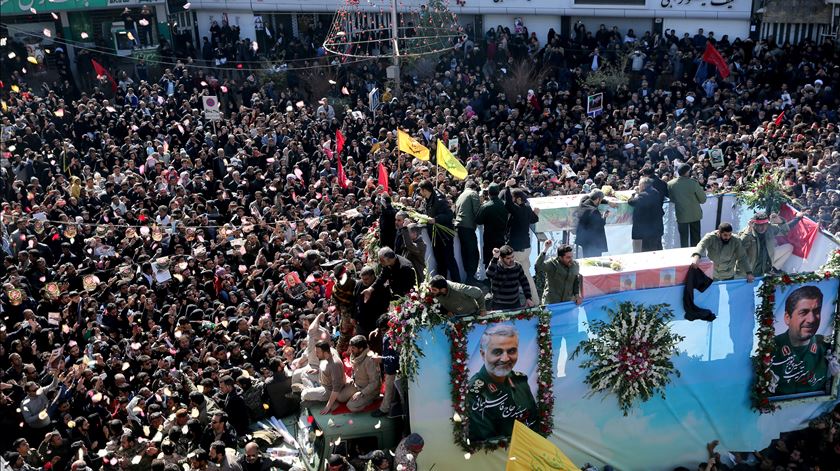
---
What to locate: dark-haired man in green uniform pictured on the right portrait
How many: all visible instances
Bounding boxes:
[771,286,829,396]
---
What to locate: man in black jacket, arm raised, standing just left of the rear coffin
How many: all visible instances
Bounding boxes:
[503,178,540,302]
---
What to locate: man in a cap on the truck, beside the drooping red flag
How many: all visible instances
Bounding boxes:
[737,211,803,276]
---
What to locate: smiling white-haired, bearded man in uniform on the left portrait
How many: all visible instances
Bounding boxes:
[467,324,538,441]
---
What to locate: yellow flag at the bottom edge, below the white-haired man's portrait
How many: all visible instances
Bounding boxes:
[505,420,580,471]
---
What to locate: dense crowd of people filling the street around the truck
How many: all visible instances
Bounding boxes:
[0,11,840,471]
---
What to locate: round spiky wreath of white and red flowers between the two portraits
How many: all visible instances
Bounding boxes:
[570,302,684,415]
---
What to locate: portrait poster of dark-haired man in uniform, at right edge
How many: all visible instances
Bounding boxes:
[771,280,837,399]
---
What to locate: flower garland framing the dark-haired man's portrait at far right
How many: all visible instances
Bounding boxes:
[751,272,840,414]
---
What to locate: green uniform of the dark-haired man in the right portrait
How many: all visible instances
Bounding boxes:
[770,332,830,396]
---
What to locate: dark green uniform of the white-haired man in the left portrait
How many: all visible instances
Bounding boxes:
[467,366,539,441]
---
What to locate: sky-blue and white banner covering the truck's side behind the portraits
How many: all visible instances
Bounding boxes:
[409,280,837,471]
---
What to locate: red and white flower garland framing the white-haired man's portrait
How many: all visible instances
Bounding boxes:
[447,307,554,453]
